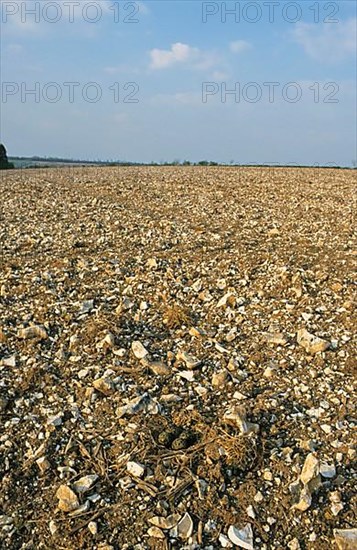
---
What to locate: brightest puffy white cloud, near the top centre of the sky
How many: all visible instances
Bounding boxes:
[150,42,220,70]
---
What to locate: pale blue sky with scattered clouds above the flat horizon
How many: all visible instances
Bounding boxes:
[0,0,357,166]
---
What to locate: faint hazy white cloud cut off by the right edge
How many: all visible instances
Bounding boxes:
[293,17,357,63]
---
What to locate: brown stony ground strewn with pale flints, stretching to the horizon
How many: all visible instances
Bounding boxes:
[0,167,357,550]
